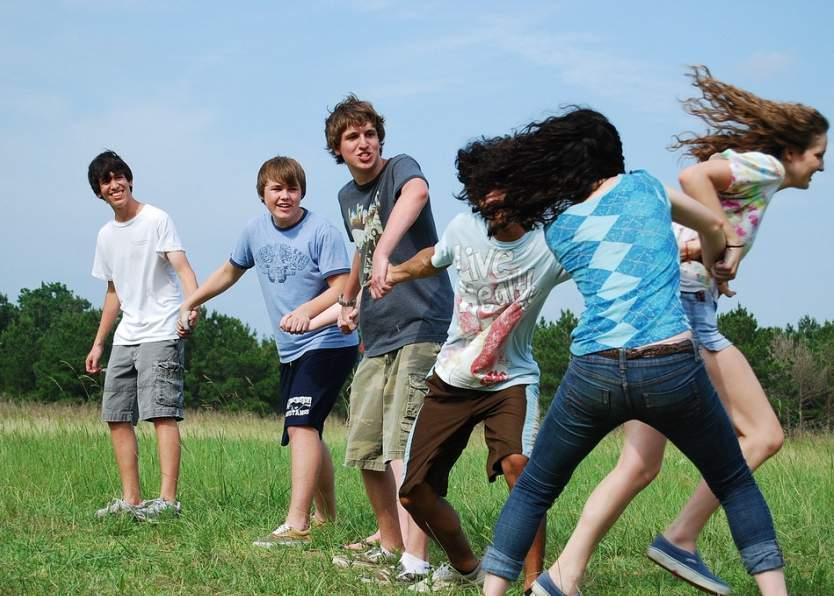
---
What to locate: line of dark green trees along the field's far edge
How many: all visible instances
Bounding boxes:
[0,282,834,432]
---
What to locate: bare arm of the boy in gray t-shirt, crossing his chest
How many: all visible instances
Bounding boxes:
[371,178,429,298]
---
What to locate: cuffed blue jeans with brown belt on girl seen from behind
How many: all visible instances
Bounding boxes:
[483,344,784,580]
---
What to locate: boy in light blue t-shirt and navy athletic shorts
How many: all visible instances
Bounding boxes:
[180,156,358,547]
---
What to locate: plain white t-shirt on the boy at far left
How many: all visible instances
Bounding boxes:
[93,203,183,346]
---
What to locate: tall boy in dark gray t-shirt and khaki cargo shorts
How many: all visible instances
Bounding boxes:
[325,95,452,581]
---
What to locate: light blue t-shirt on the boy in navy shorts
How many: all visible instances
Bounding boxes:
[229,209,359,363]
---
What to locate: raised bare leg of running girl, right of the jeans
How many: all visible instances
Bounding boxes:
[663,346,785,551]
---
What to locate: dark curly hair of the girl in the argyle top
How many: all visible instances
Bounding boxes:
[456,106,625,230]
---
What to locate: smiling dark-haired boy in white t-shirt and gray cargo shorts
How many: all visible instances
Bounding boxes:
[85,151,197,520]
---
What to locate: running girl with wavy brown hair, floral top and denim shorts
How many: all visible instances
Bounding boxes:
[528,67,828,594]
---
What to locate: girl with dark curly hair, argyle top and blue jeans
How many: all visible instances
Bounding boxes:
[468,107,786,595]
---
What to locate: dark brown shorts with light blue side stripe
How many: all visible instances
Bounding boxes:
[400,374,527,496]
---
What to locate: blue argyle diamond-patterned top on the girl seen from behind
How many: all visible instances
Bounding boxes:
[545,170,689,356]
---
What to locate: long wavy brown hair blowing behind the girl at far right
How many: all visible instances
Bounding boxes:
[670,66,828,161]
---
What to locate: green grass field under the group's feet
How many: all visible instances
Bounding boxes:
[0,401,834,596]
